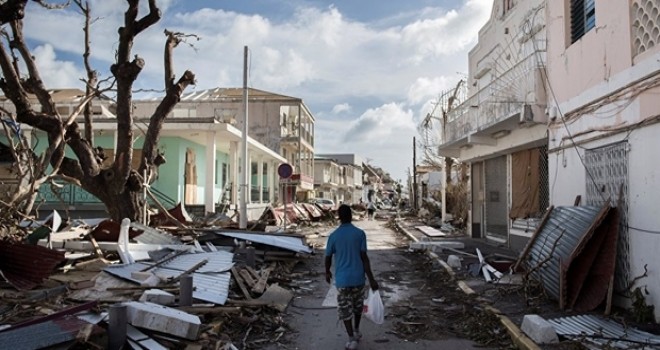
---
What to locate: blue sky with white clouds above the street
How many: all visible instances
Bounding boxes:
[15,0,493,182]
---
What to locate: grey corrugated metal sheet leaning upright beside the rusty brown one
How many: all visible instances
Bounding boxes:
[525,203,609,306]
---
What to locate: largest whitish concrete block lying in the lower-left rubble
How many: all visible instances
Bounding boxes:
[124,301,202,340]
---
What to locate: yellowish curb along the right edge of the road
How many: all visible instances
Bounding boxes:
[394,219,541,350]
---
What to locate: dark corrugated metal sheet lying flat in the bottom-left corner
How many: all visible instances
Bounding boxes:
[0,316,97,350]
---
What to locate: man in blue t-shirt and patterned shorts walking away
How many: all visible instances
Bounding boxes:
[325,204,378,349]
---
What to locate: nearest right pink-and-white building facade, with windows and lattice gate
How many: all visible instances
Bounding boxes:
[547,0,660,320]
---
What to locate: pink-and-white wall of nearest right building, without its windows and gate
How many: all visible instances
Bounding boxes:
[547,0,660,320]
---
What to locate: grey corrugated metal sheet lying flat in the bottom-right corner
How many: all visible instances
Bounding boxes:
[548,315,660,349]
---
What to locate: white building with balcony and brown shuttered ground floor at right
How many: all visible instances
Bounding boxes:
[434,0,549,250]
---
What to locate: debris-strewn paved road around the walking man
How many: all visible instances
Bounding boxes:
[271,220,496,350]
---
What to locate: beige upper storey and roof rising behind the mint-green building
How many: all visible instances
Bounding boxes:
[135,88,314,205]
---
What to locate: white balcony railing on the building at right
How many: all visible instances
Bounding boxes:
[442,52,545,144]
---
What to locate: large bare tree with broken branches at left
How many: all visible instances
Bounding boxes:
[0,0,195,221]
